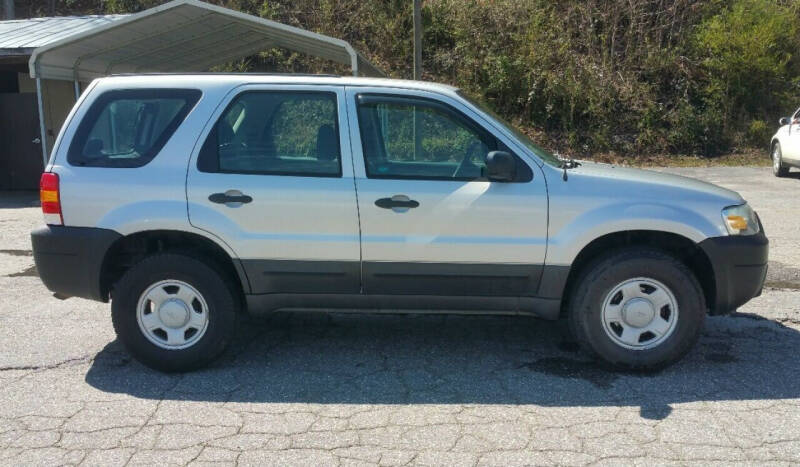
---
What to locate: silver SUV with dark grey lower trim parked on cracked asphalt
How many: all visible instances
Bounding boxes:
[32,74,767,371]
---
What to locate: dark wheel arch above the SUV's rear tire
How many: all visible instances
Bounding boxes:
[100,230,250,303]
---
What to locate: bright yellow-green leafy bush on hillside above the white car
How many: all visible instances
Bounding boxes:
[692,0,800,150]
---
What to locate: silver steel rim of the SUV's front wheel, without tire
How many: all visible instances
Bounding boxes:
[602,277,678,350]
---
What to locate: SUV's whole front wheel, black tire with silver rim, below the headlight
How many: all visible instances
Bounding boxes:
[568,248,706,370]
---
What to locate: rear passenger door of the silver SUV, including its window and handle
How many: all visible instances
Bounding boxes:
[187,85,360,294]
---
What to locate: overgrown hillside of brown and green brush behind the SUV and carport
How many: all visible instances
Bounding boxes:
[40,0,800,155]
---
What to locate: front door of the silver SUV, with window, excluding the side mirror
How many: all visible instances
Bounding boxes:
[347,87,547,297]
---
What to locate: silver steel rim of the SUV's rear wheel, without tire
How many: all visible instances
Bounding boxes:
[136,280,208,350]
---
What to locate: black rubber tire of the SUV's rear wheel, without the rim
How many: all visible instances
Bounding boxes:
[111,253,239,372]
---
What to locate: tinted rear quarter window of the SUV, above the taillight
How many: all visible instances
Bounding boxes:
[67,89,201,168]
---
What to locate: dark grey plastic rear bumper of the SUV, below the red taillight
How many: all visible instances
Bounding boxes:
[31,225,121,302]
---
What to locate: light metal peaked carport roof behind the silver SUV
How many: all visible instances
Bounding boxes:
[29,0,384,81]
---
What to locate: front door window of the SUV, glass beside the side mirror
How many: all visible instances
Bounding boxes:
[358,95,497,180]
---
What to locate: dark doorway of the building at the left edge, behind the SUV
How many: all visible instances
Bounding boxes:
[0,93,44,190]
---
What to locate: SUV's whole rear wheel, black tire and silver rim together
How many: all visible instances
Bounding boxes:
[111,254,238,372]
